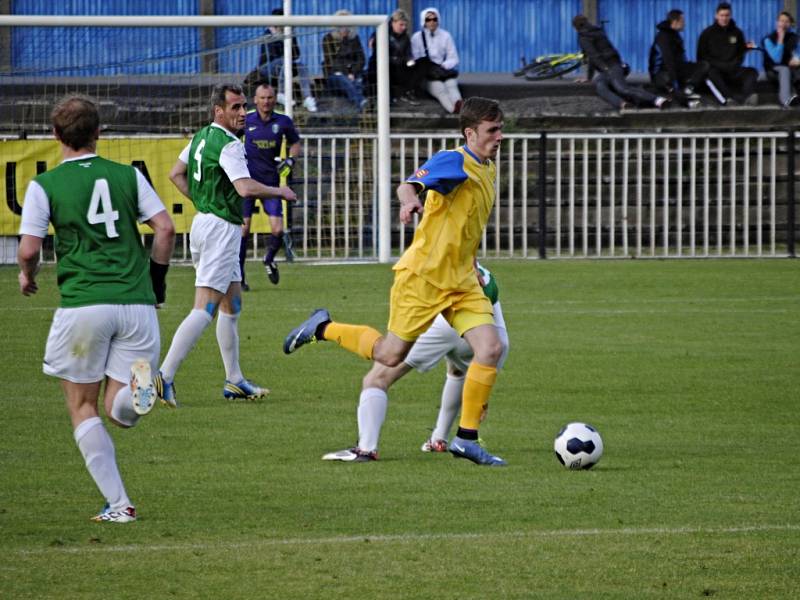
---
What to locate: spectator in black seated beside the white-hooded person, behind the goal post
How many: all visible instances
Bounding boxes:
[367,8,419,105]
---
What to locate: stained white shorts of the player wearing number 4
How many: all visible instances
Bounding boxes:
[42,304,161,383]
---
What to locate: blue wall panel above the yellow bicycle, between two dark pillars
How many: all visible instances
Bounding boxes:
[412,0,582,72]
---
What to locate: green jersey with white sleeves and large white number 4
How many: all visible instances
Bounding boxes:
[20,154,164,308]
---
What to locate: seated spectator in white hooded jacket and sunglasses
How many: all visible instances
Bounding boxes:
[411,7,462,113]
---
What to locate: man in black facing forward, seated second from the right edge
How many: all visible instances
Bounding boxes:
[697,2,758,105]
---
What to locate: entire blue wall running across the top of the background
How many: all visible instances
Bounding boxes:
[4,0,783,75]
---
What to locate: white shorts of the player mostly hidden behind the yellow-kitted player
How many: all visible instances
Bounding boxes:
[403,302,508,373]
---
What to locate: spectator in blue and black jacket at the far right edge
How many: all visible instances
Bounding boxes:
[761,11,800,108]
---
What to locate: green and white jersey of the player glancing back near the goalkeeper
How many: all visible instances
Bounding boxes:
[179,123,250,225]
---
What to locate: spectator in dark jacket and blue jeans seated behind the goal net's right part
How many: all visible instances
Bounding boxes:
[322,10,368,109]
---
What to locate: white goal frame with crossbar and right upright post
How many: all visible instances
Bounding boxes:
[0,15,392,263]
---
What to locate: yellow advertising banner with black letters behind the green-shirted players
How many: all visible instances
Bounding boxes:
[0,136,276,235]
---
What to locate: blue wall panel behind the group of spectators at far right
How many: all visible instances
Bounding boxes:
[598,0,783,72]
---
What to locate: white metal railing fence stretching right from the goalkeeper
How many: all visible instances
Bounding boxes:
[282,131,795,260]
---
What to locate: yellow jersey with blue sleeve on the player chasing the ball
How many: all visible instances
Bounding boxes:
[394,146,495,290]
